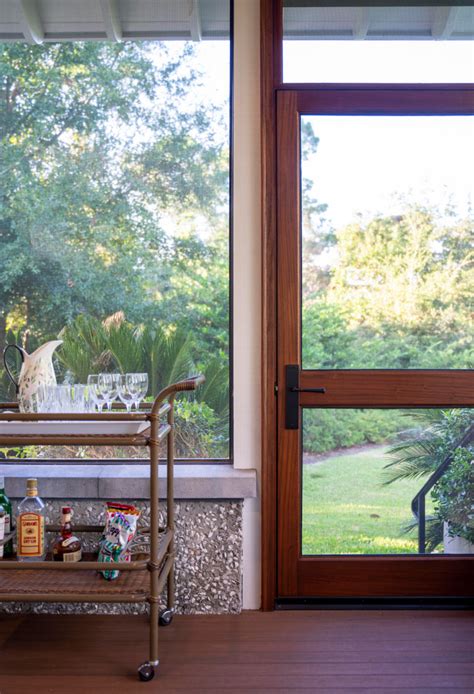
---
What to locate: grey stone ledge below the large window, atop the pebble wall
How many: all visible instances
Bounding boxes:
[0,463,257,499]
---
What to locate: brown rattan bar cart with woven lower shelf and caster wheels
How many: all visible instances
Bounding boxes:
[0,376,204,681]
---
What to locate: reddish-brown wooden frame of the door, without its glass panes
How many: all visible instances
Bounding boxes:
[276,84,474,600]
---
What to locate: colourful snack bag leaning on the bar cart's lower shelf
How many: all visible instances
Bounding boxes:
[98,501,140,581]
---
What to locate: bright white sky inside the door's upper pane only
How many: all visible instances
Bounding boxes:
[303,116,474,228]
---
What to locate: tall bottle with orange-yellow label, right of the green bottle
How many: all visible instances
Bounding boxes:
[16,479,46,561]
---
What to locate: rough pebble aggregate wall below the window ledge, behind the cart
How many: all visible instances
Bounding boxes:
[0,499,242,614]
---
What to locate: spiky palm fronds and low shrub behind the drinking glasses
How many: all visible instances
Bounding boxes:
[57,313,229,457]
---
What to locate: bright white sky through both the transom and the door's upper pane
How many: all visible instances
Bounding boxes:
[284,41,474,227]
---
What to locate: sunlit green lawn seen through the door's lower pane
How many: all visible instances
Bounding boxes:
[302,445,430,554]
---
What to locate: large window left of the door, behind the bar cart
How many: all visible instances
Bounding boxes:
[0,2,230,458]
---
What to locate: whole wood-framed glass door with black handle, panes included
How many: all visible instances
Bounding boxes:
[277,85,474,598]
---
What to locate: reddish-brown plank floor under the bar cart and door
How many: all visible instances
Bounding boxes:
[0,611,474,694]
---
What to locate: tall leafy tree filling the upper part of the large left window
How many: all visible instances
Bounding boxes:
[0,42,228,346]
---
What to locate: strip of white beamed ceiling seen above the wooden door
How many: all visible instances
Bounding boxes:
[283,0,474,40]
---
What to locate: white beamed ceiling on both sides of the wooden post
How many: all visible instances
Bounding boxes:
[0,0,474,43]
